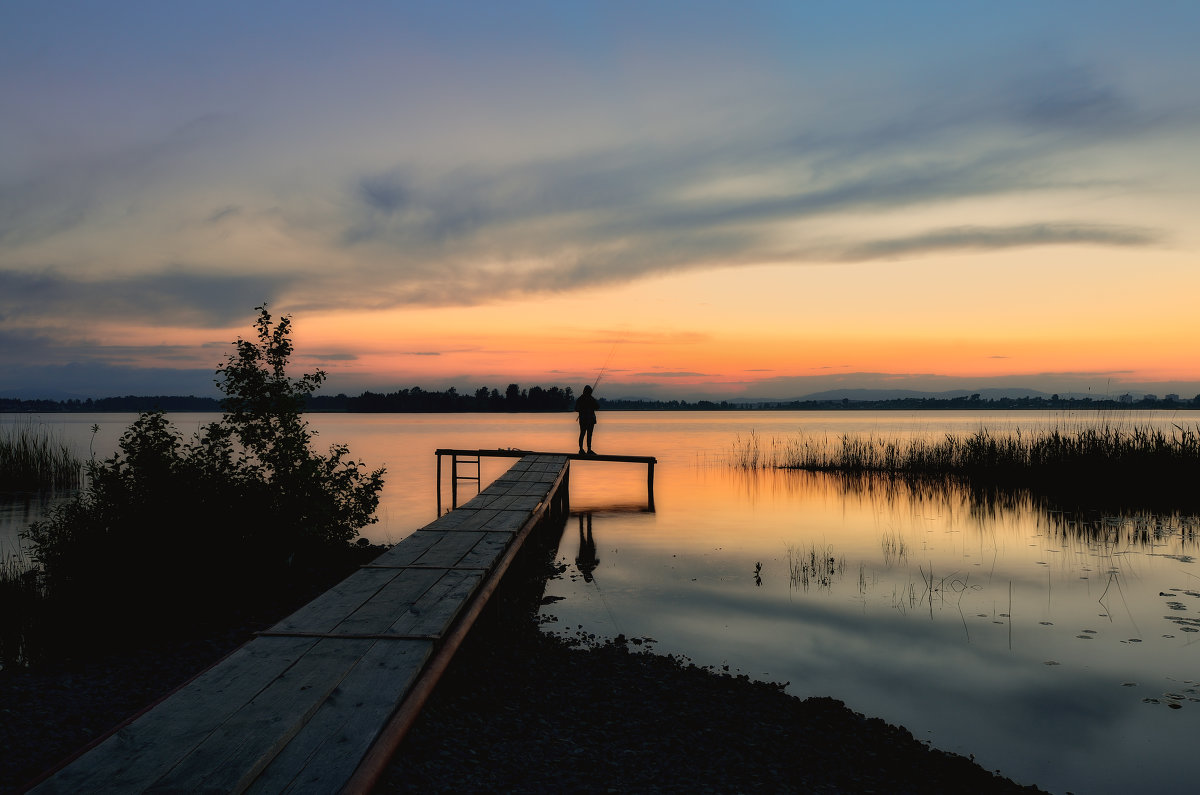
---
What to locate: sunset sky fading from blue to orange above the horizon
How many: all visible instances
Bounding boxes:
[0,0,1200,400]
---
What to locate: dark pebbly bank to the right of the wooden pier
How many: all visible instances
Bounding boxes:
[378,547,1038,793]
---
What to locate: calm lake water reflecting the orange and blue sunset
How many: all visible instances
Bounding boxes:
[0,412,1200,793]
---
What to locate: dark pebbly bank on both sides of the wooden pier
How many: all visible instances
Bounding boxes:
[0,538,1033,793]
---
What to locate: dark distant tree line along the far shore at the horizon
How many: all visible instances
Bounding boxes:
[7,384,1200,413]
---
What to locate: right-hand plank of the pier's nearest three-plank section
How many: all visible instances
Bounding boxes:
[247,640,433,794]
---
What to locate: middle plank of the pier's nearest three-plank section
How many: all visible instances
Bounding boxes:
[148,639,374,793]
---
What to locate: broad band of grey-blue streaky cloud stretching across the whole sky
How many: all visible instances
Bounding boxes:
[0,50,1186,336]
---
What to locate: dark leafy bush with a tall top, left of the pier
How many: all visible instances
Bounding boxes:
[26,306,384,634]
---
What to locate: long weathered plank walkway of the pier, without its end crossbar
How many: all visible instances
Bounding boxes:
[32,450,572,794]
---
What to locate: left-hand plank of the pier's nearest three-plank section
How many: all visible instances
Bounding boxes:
[31,638,317,795]
